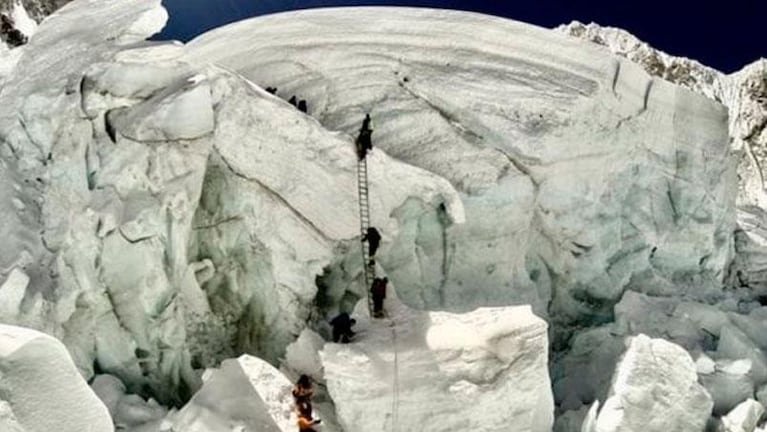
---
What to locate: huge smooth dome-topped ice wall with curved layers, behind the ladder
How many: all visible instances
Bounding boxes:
[186,8,736,338]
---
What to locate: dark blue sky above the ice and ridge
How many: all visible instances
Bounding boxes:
[156,0,767,72]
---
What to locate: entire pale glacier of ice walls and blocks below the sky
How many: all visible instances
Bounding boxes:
[0,0,767,432]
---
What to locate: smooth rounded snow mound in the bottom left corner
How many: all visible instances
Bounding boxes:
[0,324,114,432]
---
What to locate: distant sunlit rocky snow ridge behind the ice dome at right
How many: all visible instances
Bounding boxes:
[556,21,767,295]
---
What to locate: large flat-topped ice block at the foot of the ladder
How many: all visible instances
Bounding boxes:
[321,289,554,432]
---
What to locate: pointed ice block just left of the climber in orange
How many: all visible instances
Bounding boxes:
[170,355,297,432]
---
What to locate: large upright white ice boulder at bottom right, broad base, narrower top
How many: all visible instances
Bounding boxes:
[595,335,713,432]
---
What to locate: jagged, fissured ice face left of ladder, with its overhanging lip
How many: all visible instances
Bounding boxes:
[0,0,464,404]
